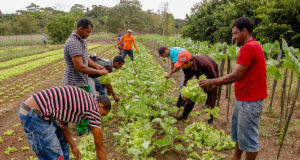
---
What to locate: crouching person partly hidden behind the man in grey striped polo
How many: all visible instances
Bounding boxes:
[90,56,125,102]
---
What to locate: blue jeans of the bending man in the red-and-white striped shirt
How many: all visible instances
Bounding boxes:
[18,104,70,160]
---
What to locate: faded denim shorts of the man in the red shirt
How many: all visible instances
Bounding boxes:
[231,100,264,152]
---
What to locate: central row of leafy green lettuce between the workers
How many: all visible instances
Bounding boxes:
[79,44,234,160]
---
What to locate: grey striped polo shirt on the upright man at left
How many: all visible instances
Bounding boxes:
[63,31,89,86]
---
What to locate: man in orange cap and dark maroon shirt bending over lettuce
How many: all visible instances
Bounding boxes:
[175,51,219,125]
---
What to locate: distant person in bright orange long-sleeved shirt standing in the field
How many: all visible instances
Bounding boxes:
[115,29,139,61]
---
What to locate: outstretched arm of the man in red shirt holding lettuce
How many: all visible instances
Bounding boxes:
[199,64,248,87]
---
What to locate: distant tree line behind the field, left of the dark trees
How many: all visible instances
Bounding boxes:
[0,0,184,42]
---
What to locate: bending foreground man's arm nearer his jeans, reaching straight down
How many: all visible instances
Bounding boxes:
[59,121,81,160]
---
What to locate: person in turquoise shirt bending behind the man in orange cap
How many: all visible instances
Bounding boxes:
[157,47,185,108]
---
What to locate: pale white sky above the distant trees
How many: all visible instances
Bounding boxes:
[0,0,201,19]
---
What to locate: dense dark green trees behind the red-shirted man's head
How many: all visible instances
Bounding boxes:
[183,0,300,48]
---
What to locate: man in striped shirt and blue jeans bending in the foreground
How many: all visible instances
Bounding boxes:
[19,86,111,160]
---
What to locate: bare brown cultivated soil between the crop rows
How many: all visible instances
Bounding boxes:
[0,41,300,160]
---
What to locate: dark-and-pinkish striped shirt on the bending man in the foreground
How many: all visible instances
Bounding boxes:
[32,86,101,129]
